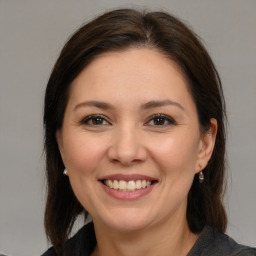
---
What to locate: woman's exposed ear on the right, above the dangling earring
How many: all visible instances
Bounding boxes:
[196,118,218,173]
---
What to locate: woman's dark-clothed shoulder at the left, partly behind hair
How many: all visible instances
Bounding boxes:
[41,222,96,256]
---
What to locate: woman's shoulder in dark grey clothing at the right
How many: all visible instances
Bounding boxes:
[188,226,256,256]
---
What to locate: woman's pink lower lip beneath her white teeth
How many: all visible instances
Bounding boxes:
[101,183,156,200]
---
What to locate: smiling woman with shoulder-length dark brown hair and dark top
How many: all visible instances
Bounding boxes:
[41,9,256,256]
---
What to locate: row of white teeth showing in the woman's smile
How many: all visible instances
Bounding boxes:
[104,180,151,191]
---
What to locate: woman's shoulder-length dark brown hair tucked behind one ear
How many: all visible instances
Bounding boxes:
[44,9,227,253]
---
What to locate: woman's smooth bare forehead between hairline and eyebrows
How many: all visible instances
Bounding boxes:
[70,48,194,109]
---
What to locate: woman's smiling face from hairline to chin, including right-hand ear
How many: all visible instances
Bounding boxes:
[57,48,216,231]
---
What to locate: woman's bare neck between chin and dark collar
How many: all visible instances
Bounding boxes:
[92,214,198,256]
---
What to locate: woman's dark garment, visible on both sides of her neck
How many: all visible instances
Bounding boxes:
[42,222,256,256]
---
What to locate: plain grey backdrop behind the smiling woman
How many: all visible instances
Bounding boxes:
[0,0,256,256]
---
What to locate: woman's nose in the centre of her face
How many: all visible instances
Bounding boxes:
[108,124,147,166]
